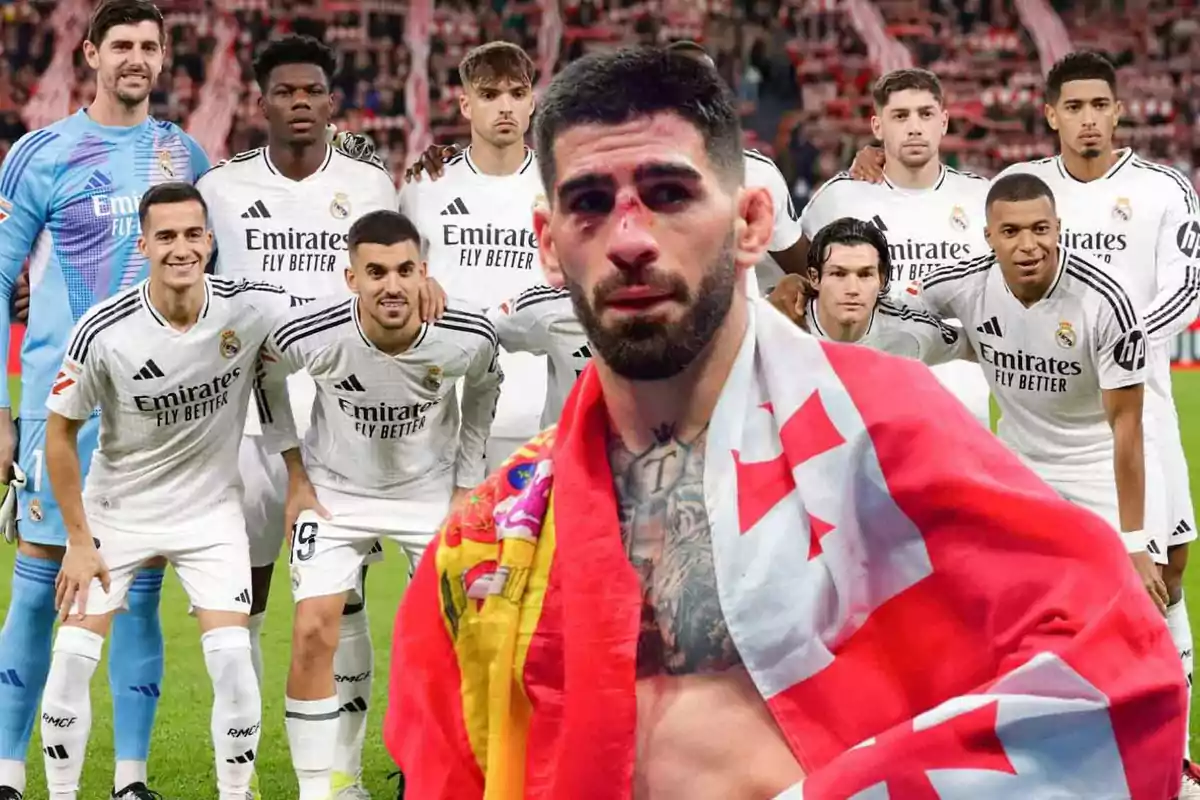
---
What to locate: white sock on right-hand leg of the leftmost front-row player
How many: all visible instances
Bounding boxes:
[200,626,263,800]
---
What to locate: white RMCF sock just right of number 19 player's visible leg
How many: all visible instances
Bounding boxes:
[334,609,374,778]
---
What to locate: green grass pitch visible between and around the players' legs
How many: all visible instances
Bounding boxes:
[0,372,1200,800]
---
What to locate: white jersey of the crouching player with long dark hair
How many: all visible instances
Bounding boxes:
[808,297,974,366]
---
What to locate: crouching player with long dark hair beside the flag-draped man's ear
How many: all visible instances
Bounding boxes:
[787,217,974,366]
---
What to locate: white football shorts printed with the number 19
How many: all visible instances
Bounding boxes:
[289,486,450,602]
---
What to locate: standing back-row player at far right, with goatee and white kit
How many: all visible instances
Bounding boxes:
[988,52,1200,767]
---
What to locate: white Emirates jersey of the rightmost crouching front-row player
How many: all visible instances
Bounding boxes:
[906,247,1146,471]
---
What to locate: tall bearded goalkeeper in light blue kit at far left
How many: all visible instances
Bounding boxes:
[0,0,209,800]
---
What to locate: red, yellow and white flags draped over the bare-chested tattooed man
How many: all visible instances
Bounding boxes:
[385,301,1186,800]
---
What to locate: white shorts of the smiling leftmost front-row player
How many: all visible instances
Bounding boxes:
[75,500,250,614]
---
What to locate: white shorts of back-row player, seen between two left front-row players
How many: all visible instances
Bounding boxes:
[238,437,383,569]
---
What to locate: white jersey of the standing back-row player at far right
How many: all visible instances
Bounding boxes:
[997,149,1200,408]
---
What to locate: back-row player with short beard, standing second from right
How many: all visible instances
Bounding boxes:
[800,70,989,426]
